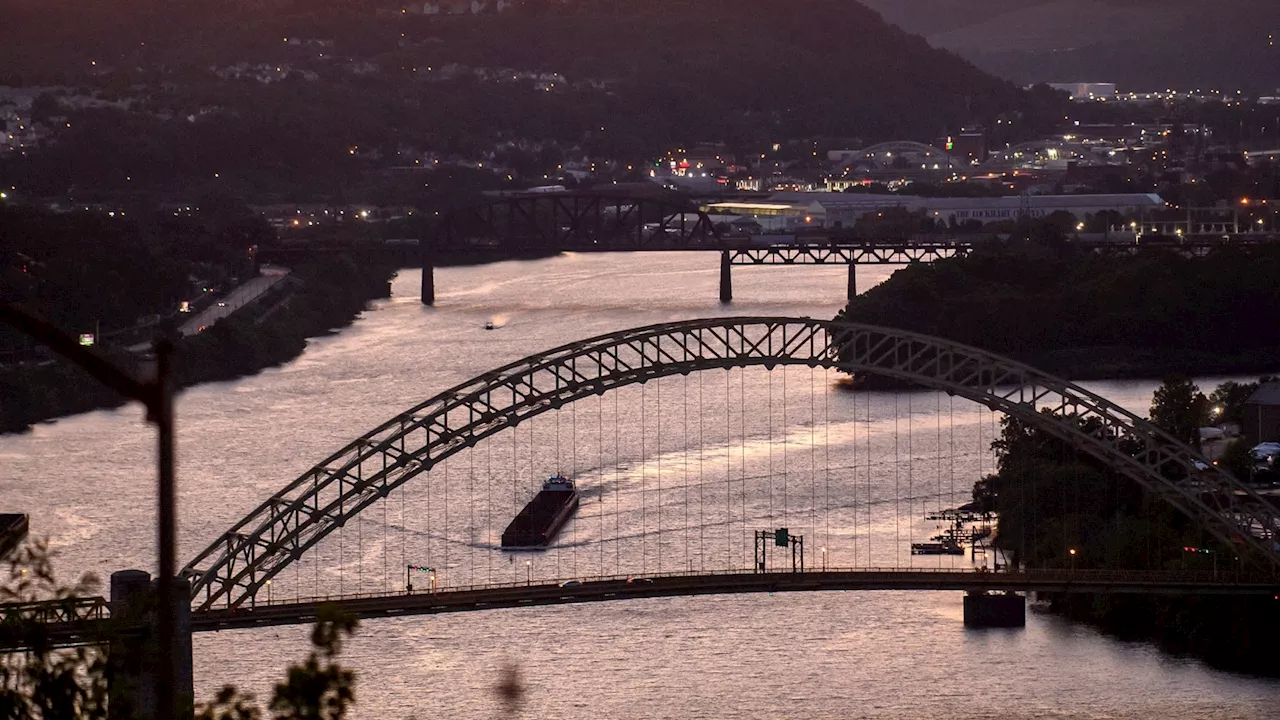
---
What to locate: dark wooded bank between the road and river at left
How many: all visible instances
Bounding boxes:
[0,255,396,433]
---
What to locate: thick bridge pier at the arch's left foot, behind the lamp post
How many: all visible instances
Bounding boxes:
[108,570,195,720]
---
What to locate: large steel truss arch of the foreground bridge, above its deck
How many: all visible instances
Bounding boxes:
[182,318,1280,610]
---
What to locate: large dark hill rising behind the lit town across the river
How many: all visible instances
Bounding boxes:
[0,0,1066,178]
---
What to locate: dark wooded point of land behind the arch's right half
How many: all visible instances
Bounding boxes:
[841,243,1280,380]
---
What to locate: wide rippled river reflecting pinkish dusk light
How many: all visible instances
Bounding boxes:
[0,254,1280,720]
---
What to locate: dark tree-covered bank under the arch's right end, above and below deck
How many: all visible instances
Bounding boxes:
[974,407,1280,678]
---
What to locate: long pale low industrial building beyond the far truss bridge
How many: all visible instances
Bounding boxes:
[703,192,1165,232]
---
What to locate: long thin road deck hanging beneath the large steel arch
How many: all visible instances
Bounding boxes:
[192,569,1280,632]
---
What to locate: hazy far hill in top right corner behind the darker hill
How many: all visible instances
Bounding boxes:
[861,0,1280,91]
